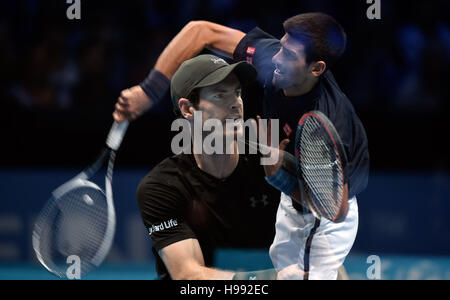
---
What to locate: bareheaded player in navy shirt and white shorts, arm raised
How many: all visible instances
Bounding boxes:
[117,13,369,279]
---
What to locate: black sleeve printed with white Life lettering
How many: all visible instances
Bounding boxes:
[136,178,196,251]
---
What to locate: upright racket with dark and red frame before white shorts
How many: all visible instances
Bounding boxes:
[295,111,348,223]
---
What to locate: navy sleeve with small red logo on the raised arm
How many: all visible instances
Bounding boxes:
[233,27,281,84]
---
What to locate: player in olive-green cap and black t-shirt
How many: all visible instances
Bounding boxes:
[137,55,292,279]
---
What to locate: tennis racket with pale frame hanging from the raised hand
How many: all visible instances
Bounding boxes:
[32,121,128,278]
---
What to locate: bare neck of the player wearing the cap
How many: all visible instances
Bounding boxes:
[194,143,239,179]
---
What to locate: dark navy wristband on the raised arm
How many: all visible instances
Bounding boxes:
[139,69,170,104]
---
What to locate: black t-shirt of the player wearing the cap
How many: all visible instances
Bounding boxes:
[137,154,280,279]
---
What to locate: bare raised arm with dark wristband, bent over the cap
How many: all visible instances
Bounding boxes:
[113,21,245,122]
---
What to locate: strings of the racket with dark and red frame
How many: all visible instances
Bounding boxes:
[300,118,343,216]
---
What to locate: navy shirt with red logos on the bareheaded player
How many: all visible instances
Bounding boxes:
[233,28,369,197]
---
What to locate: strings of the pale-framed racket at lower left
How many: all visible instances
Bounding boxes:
[37,187,108,277]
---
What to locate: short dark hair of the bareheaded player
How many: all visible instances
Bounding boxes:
[283,13,347,67]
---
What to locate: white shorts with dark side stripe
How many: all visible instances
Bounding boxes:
[270,193,358,280]
